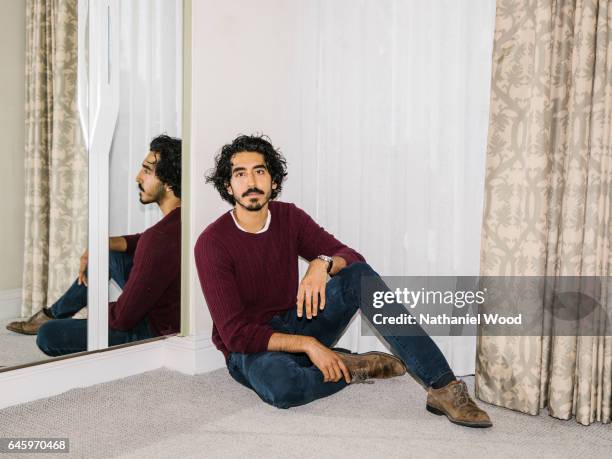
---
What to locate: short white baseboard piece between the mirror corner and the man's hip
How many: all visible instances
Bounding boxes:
[164,336,225,375]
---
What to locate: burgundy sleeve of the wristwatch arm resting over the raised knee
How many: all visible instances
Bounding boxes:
[294,206,365,266]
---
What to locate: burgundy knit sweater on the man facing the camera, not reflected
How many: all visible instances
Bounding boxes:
[195,201,364,358]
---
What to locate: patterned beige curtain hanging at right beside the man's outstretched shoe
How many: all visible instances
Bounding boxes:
[476,0,612,425]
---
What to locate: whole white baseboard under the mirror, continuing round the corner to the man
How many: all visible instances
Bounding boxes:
[0,336,225,409]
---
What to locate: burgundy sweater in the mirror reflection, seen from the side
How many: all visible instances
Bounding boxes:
[108,207,181,336]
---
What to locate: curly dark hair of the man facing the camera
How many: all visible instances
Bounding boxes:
[206,135,287,205]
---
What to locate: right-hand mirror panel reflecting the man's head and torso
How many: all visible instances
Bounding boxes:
[108,0,183,345]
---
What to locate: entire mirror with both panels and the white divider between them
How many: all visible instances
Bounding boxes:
[0,0,182,371]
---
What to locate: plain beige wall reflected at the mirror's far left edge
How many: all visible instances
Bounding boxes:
[0,0,26,291]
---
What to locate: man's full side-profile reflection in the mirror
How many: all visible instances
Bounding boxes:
[7,135,181,356]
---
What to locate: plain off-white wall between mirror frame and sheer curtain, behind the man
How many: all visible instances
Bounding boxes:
[190,0,302,336]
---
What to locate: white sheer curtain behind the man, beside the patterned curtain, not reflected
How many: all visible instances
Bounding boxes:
[282,0,495,375]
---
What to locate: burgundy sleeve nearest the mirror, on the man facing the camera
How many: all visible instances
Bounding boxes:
[194,233,274,354]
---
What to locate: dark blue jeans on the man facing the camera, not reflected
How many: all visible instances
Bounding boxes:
[227,263,454,408]
